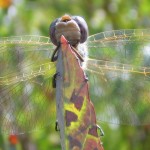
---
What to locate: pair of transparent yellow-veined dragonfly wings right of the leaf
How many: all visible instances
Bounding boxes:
[85,29,150,125]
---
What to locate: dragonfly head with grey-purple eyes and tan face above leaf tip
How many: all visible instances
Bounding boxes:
[50,14,88,47]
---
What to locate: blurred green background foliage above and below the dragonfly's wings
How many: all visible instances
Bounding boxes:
[0,0,150,150]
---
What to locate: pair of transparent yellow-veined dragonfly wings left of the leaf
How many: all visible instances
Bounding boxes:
[0,36,56,134]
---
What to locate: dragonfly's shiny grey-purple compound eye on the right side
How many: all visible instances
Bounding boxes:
[72,16,88,43]
